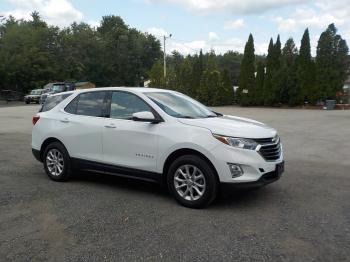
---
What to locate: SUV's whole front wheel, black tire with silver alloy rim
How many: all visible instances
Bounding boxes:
[167,155,218,208]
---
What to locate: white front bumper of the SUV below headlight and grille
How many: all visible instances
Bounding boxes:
[211,142,284,183]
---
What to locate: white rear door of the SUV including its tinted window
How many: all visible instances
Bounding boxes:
[58,91,107,162]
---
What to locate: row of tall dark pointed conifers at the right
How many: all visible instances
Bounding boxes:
[237,24,349,106]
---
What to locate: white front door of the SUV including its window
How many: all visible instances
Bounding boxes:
[102,91,159,172]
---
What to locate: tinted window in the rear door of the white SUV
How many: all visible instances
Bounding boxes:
[65,92,106,117]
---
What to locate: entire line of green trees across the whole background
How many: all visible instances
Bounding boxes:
[0,12,349,106]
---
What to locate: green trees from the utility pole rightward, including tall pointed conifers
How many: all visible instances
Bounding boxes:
[149,24,349,106]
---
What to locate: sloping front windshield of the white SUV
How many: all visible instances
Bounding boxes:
[144,92,217,118]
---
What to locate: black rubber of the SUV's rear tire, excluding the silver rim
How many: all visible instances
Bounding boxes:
[43,142,71,182]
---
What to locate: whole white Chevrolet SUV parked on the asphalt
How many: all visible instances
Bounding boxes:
[32,87,284,207]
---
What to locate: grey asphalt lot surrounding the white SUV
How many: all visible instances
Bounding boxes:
[0,105,350,261]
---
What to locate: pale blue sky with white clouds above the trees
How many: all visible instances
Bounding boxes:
[0,0,350,55]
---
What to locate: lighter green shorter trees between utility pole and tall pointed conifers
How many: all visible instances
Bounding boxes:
[149,51,249,106]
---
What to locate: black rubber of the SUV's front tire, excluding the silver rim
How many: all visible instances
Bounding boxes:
[167,155,219,208]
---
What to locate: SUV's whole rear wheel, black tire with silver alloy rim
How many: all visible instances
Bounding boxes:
[43,142,71,181]
